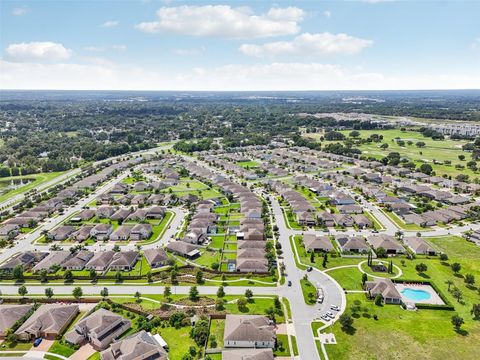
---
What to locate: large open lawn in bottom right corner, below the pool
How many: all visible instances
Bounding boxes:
[327,294,480,360]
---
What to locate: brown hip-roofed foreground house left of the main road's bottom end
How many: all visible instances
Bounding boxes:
[223,314,276,349]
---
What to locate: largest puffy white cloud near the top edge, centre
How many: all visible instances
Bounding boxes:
[135,5,305,39]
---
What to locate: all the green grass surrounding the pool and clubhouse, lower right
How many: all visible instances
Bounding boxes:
[327,236,480,360]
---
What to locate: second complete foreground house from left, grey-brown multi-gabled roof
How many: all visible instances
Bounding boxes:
[65,309,131,350]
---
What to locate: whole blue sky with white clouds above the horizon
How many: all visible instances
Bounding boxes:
[0,0,480,91]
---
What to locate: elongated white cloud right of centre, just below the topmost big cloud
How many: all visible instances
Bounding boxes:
[239,32,373,57]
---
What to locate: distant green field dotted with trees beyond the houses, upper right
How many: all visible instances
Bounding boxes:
[305,129,477,177]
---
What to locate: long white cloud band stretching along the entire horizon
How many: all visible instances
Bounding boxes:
[0,58,480,91]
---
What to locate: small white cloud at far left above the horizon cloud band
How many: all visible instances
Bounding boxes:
[5,41,72,62]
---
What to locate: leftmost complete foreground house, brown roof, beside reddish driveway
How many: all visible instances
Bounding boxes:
[15,303,79,341]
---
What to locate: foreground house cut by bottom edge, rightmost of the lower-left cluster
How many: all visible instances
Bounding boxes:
[100,330,168,360]
